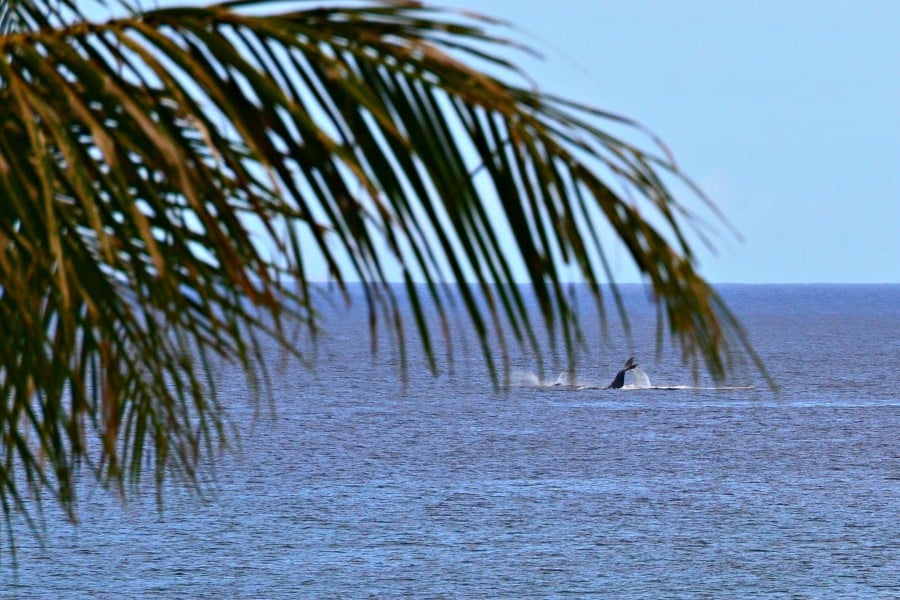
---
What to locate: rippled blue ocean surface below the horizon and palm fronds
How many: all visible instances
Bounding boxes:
[0,285,900,599]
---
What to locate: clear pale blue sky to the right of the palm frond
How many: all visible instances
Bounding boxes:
[437,0,900,283]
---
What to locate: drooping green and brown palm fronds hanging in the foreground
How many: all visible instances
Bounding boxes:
[0,0,768,548]
